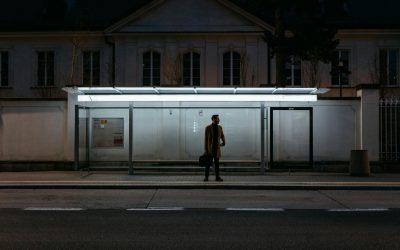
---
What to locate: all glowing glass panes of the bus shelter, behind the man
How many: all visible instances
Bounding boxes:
[78,103,311,172]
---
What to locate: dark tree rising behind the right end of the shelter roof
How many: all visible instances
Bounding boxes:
[248,0,346,86]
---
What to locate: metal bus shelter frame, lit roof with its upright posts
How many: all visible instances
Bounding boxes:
[64,87,329,174]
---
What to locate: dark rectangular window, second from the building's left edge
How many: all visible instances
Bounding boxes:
[36,51,54,86]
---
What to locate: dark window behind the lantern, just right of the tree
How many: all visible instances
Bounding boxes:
[331,50,350,86]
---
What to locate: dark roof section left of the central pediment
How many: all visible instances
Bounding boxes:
[0,0,150,32]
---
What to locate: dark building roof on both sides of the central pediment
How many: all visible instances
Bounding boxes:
[0,0,400,32]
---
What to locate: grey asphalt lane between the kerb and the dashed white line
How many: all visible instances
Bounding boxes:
[0,189,400,209]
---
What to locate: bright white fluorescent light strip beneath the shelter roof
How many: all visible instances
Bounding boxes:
[78,94,317,102]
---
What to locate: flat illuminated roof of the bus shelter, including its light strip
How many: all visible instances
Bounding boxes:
[64,87,329,102]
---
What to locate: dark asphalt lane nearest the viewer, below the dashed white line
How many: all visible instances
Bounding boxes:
[0,209,400,250]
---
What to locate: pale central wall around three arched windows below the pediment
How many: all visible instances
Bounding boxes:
[116,34,268,87]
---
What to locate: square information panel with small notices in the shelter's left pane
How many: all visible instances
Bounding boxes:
[93,118,124,148]
